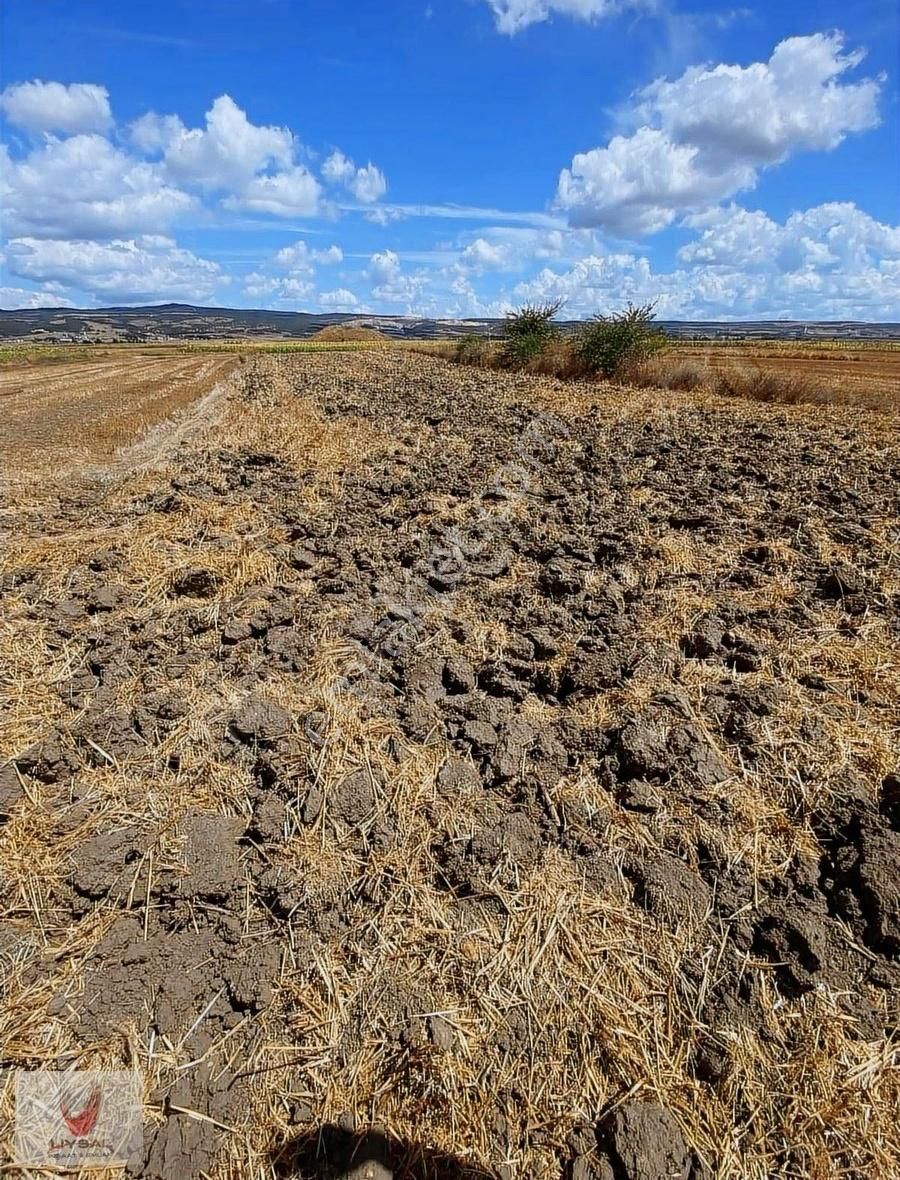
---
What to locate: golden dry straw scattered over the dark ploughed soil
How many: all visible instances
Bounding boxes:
[0,352,900,1180]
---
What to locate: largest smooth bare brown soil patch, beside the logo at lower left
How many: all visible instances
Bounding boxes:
[43,815,281,1180]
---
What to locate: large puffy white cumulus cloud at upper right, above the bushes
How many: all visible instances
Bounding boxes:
[557,33,880,235]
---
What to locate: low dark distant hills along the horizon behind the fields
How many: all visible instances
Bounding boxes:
[0,303,900,343]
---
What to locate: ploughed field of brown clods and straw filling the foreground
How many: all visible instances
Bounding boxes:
[0,352,900,1180]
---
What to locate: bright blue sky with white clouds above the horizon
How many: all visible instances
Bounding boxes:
[0,0,900,320]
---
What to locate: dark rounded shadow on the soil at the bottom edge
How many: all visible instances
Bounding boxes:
[272,1123,495,1180]
